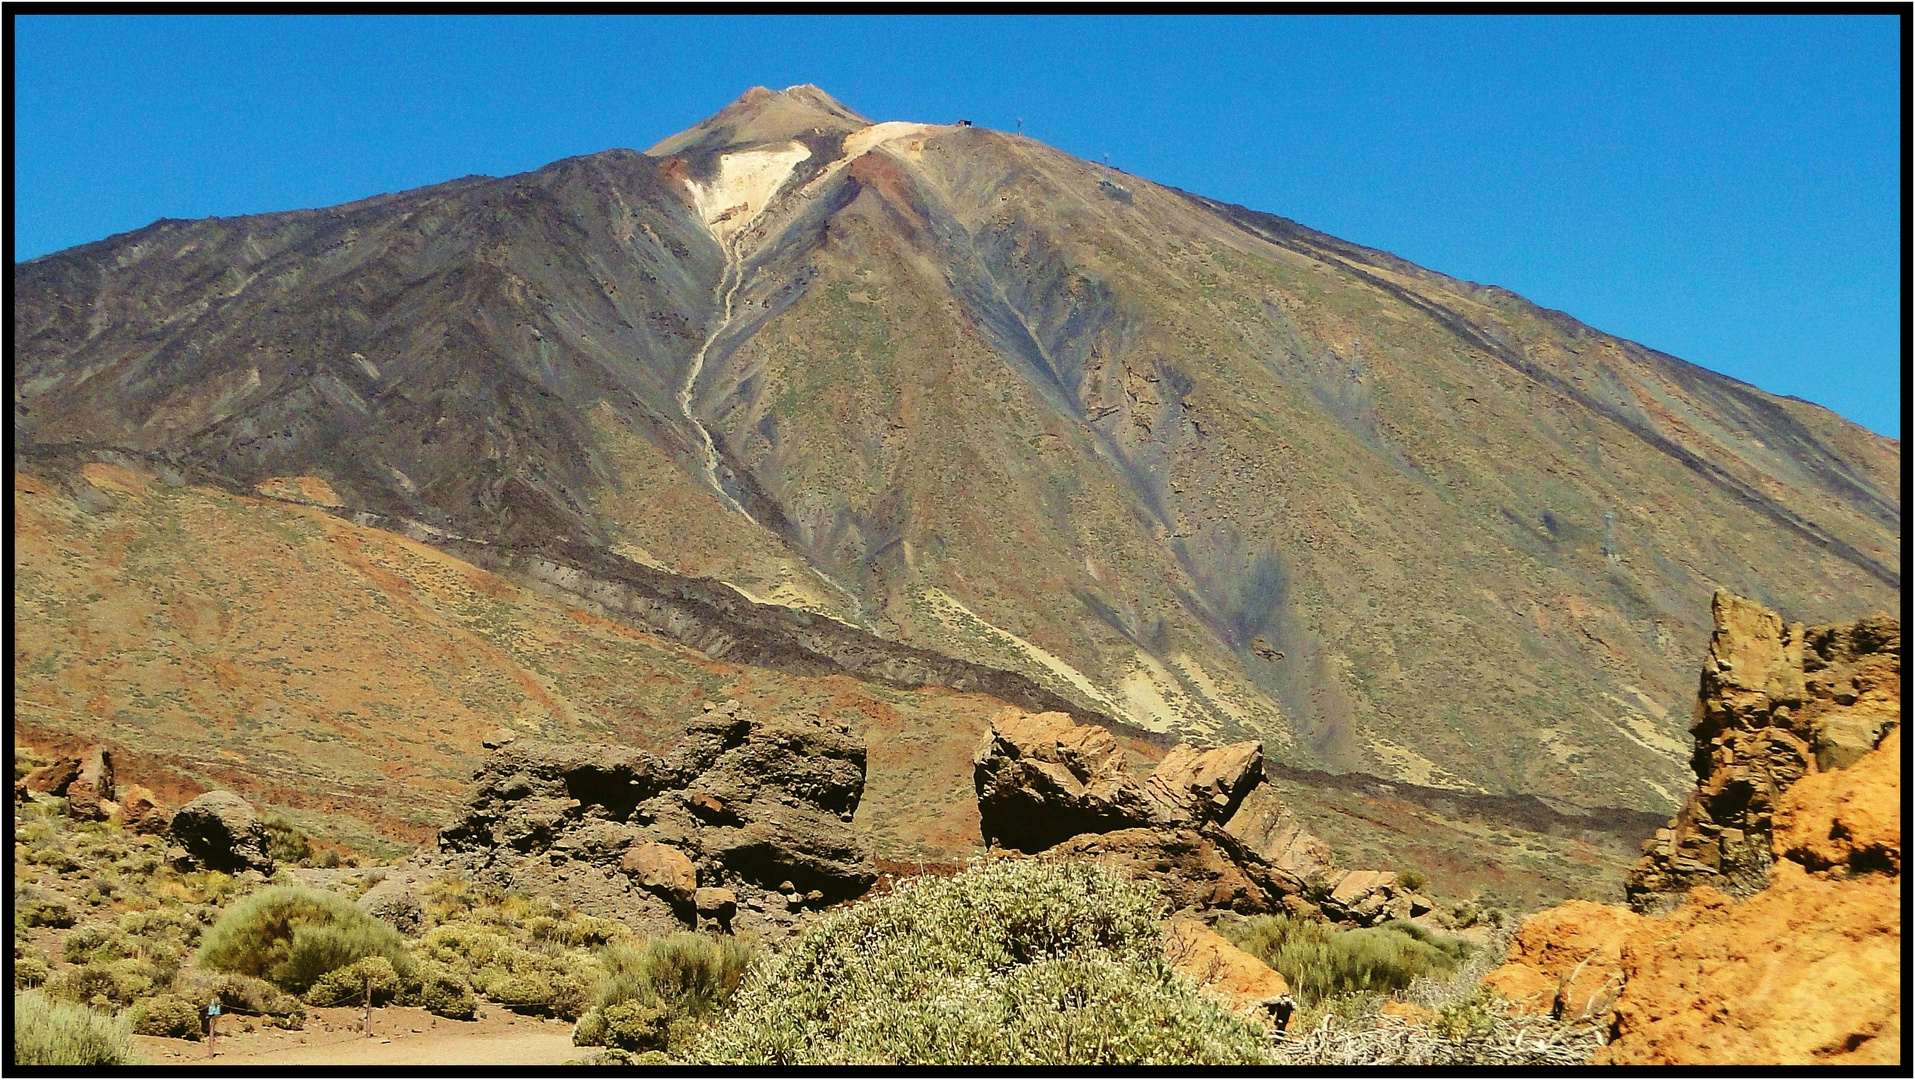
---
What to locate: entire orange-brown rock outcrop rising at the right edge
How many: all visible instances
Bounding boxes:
[1486,594,1902,1067]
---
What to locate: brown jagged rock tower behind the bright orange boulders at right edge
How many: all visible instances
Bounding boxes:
[1626,592,1902,913]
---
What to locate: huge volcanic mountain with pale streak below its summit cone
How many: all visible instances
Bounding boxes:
[13,86,1902,812]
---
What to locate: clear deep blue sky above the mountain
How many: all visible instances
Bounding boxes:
[13,15,1902,439]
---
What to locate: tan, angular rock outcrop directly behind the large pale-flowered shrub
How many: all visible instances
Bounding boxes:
[975,712,1327,913]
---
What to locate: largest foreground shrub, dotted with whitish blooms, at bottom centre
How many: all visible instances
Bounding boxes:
[691,860,1266,1067]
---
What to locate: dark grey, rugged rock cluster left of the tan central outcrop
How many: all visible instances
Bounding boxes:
[433,701,877,934]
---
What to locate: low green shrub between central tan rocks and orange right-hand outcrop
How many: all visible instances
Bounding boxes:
[1237,915,1467,1003]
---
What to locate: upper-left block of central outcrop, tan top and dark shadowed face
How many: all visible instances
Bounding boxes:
[973,712,1178,852]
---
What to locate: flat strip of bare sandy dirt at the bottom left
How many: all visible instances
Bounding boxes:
[134,1005,592,1067]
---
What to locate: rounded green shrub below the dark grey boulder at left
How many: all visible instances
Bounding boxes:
[199,887,412,994]
